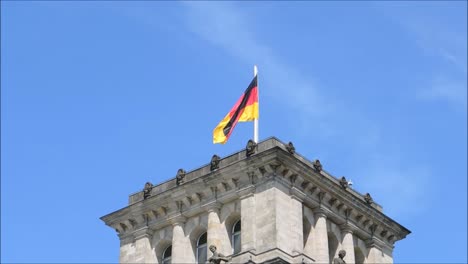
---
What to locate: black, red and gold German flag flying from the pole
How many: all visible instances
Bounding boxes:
[213,75,258,144]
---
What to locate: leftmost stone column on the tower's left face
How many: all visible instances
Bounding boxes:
[134,227,157,263]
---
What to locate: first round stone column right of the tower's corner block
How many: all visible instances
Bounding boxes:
[313,208,330,263]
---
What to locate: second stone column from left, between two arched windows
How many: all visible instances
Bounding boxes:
[171,216,195,263]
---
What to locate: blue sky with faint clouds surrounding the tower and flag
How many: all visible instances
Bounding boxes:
[1,1,467,263]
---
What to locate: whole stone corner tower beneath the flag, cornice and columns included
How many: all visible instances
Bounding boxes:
[101,138,410,263]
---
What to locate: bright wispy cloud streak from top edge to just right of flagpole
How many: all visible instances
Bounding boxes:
[181,2,333,118]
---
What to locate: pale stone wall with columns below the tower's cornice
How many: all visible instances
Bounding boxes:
[114,186,393,263]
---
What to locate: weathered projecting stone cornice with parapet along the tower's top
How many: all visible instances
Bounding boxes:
[101,138,410,248]
